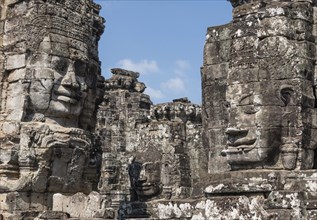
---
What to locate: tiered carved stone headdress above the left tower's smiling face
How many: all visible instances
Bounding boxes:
[5,0,104,61]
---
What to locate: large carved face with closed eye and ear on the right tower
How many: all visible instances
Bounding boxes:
[223,80,302,169]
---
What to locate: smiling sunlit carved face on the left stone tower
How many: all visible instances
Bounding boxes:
[27,38,100,127]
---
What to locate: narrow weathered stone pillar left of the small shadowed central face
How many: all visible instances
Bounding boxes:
[96,68,152,210]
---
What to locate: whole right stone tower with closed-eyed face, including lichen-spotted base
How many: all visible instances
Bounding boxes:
[201,0,317,219]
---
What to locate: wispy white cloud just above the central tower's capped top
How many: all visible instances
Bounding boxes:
[118,59,159,74]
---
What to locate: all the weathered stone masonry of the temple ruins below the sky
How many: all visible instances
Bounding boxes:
[0,0,317,220]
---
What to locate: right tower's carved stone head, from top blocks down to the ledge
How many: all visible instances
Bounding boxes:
[202,1,316,172]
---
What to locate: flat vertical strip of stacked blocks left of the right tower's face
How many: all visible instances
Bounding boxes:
[201,24,231,173]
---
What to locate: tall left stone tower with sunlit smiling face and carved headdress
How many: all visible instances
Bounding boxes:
[0,0,104,219]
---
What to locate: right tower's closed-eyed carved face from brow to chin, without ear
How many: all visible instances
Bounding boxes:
[223,85,282,167]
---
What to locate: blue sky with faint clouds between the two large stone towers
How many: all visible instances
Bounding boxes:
[95,0,232,104]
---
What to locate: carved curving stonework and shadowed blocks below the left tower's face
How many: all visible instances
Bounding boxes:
[19,123,96,192]
